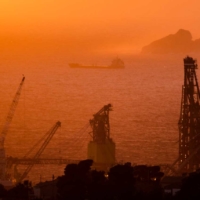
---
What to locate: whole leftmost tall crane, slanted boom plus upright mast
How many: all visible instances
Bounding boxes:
[0,77,25,180]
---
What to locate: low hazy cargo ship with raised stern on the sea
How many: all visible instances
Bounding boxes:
[69,58,125,69]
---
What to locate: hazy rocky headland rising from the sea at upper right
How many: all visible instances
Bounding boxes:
[141,29,200,54]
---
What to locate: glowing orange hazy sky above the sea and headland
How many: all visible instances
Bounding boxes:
[0,0,200,57]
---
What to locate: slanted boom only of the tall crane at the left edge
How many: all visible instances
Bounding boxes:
[0,77,25,148]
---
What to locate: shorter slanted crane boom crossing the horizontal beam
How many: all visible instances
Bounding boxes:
[18,121,61,182]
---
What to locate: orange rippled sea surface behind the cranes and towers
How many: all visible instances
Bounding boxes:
[0,55,200,181]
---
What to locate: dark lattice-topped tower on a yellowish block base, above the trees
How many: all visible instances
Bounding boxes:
[88,104,115,170]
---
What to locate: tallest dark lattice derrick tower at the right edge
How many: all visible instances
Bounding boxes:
[178,56,200,173]
